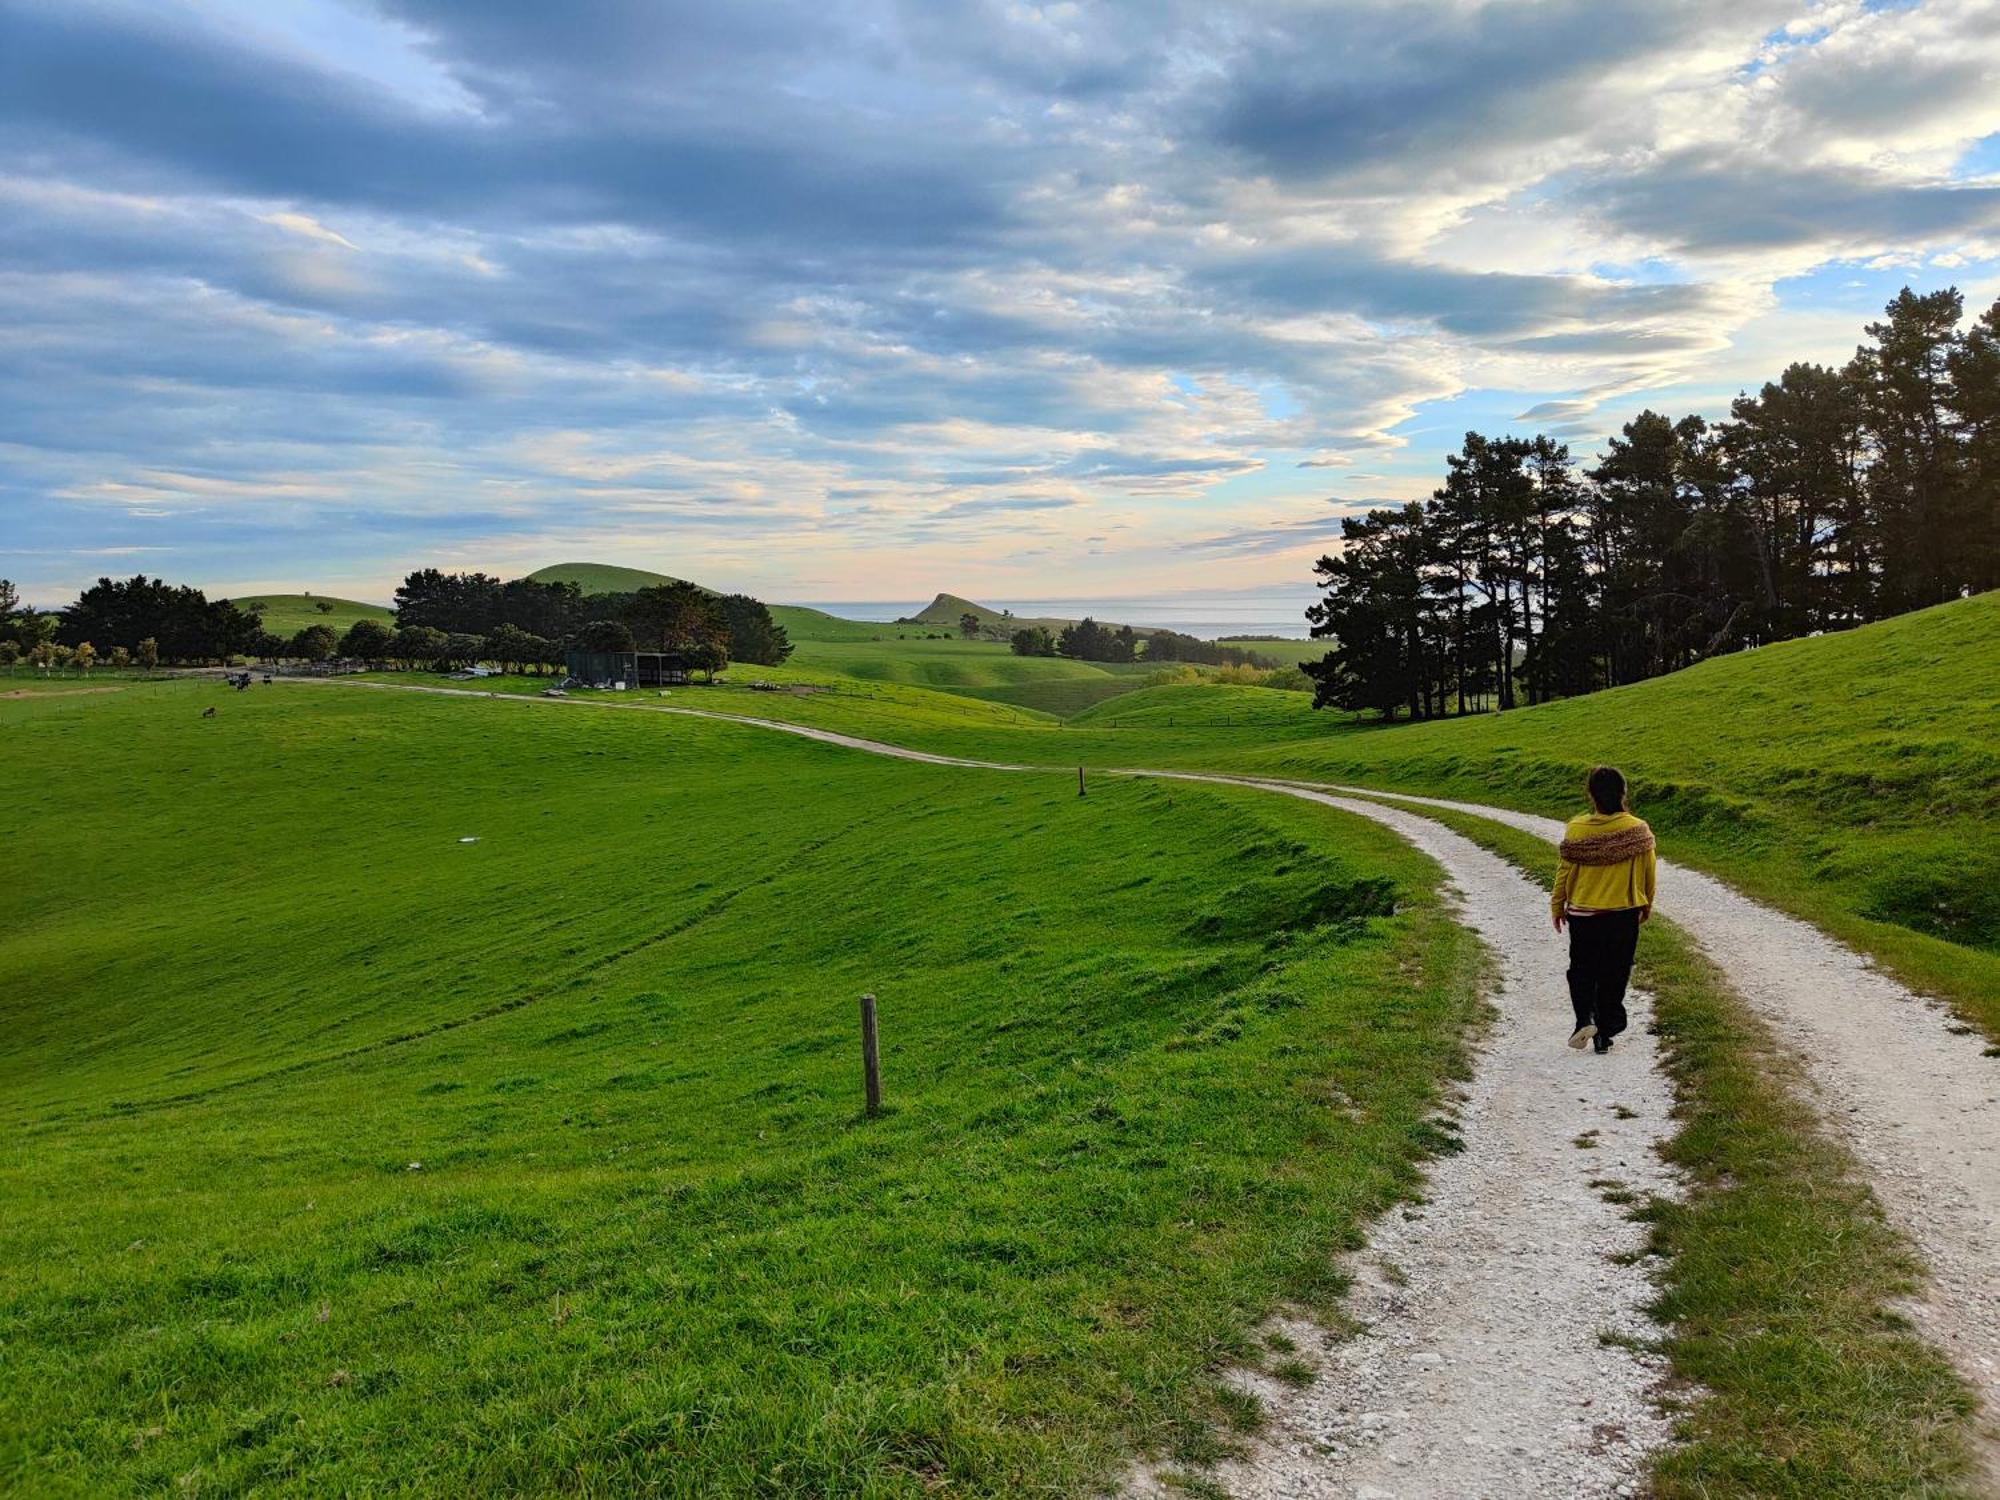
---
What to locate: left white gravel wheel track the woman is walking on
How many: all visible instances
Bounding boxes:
[1136,776,1676,1500]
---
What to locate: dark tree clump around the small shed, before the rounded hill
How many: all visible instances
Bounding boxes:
[396,568,792,676]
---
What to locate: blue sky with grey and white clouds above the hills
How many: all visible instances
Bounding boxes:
[0,0,2000,602]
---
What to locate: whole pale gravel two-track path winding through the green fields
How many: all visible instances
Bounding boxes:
[296,684,2000,1500]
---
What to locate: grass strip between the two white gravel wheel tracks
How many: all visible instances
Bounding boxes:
[1392,808,1974,1500]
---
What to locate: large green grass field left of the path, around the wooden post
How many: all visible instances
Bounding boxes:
[0,682,1472,1496]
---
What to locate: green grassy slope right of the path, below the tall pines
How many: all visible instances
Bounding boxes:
[1224,594,2000,1034]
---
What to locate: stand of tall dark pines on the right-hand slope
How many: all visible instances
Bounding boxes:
[1306,290,2000,718]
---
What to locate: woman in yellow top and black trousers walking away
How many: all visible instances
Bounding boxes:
[1550,766,1658,1052]
